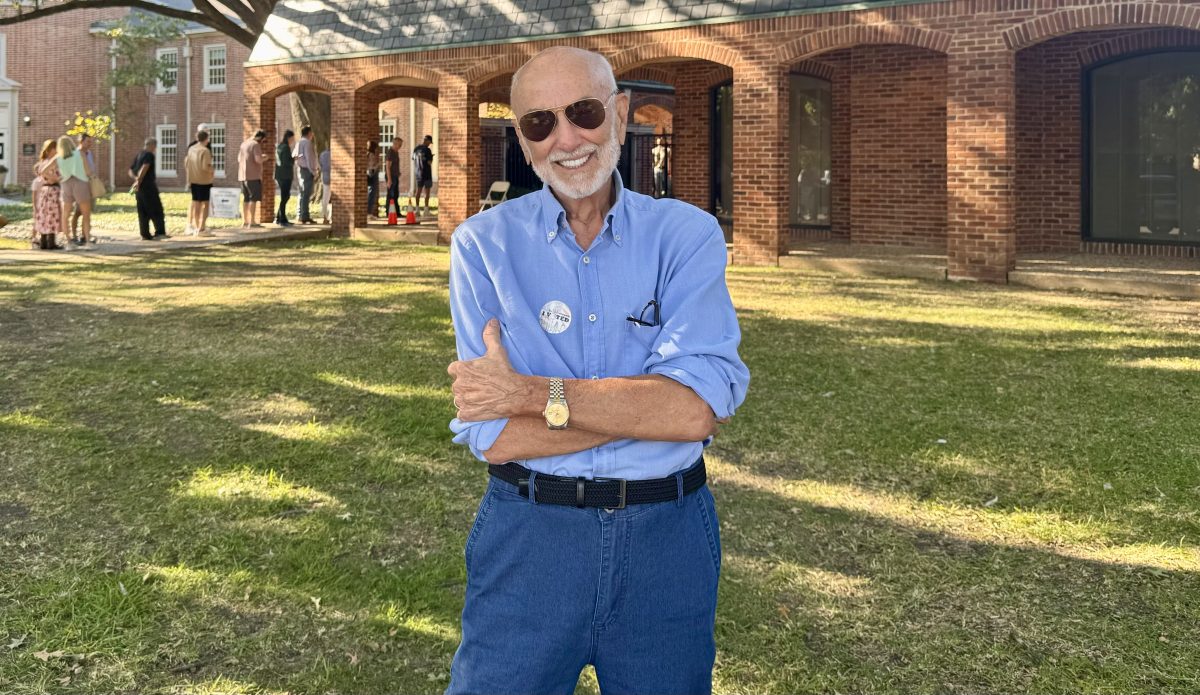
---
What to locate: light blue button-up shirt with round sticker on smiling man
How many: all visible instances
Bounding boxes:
[450,175,750,480]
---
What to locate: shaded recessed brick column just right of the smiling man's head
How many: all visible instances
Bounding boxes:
[671,62,713,210]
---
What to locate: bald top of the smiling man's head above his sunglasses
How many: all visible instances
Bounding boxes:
[511,46,617,115]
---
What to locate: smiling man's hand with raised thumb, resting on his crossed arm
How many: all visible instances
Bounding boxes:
[446,318,529,423]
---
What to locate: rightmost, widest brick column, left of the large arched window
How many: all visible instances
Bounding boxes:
[946,46,1016,282]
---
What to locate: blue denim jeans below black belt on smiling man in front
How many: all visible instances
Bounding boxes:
[446,478,721,695]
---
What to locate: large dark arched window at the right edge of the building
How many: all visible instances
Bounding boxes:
[1085,52,1200,244]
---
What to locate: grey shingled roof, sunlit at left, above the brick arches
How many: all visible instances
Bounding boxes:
[248,0,912,64]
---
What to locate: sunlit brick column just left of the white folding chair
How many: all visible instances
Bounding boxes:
[438,78,482,244]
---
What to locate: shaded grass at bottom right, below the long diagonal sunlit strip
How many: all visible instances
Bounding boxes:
[713,474,1200,693]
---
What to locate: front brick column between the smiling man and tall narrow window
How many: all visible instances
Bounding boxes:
[733,62,788,265]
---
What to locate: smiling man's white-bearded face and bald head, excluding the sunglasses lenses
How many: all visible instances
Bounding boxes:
[512,47,629,199]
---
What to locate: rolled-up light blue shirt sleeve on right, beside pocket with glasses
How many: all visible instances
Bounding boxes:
[643,221,750,418]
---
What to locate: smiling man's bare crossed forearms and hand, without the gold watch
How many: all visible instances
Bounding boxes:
[446,319,720,463]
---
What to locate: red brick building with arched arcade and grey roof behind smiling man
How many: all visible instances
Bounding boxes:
[245,0,1200,281]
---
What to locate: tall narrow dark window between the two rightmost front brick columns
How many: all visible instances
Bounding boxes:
[788,74,833,227]
